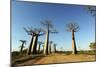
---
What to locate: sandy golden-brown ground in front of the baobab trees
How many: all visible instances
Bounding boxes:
[14,53,95,65]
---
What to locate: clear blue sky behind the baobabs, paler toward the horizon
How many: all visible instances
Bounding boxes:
[12,1,95,51]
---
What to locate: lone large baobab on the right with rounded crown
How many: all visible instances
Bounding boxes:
[66,23,80,54]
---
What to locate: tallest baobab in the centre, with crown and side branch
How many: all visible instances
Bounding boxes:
[41,20,57,55]
